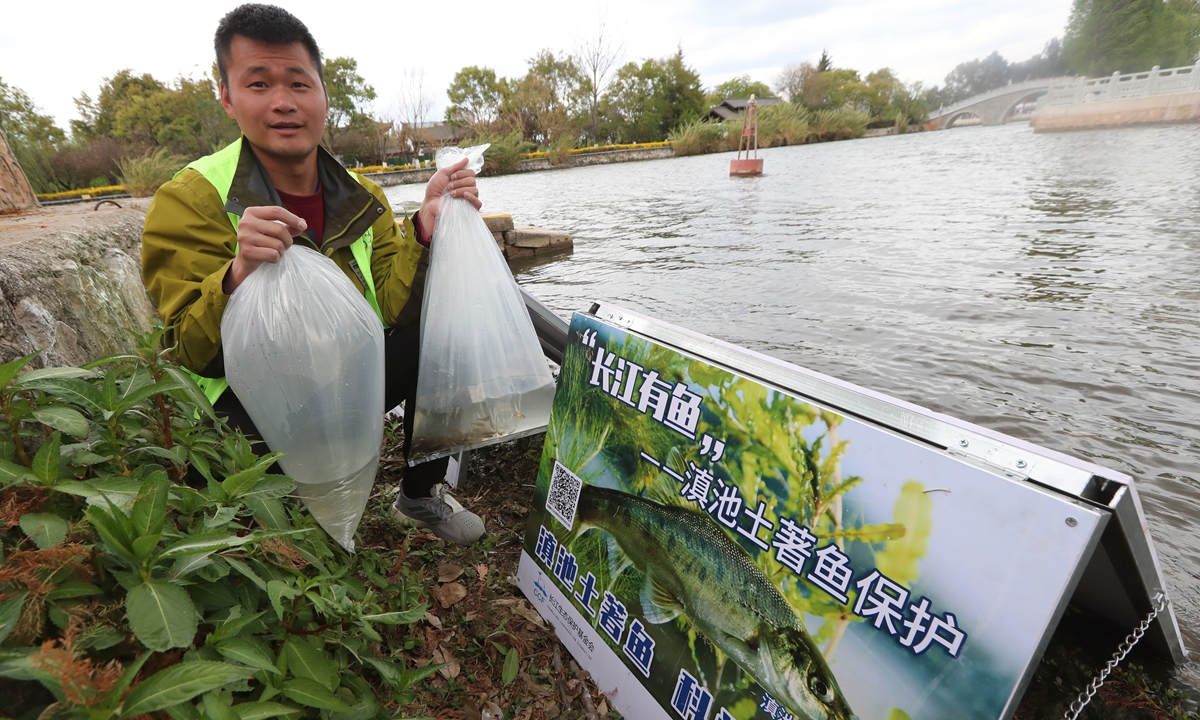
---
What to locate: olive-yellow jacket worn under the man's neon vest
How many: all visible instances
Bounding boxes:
[142,139,428,378]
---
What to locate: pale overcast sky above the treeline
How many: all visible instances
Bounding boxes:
[0,0,1070,128]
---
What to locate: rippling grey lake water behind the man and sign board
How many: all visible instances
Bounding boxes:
[389,124,1200,684]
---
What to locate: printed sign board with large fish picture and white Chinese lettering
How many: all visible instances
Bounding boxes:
[518,306,1178,720]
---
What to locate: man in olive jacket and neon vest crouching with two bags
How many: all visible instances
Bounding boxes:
[142,4,485,545]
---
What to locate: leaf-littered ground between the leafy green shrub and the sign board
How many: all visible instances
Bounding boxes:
[359,422,620,720]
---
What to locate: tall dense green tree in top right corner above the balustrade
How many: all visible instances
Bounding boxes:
[1063,0,1200,77]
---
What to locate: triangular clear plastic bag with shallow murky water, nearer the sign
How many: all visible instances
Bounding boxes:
[408,145,554,464]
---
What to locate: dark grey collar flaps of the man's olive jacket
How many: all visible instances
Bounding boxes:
[224,137,385,254]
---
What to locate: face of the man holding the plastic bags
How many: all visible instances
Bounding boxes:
[221,35,329,160]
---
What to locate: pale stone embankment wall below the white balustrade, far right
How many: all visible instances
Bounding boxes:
[1030,92,1200,132]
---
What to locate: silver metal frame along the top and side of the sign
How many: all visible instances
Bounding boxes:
[586,302,1188,681]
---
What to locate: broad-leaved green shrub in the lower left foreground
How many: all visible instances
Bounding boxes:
[0,328,432,720]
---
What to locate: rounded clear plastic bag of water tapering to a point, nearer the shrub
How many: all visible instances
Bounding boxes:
[221,245,384,552]
